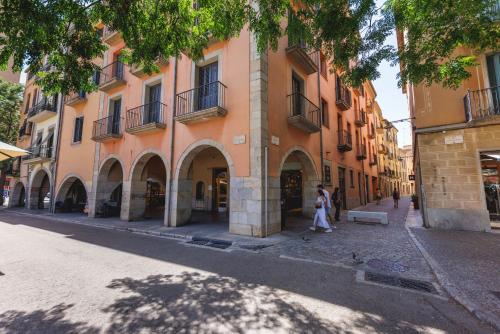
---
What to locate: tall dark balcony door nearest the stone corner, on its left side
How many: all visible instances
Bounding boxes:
[198,62,219,110]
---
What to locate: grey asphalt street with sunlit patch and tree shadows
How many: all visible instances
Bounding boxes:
[0,211,493,333]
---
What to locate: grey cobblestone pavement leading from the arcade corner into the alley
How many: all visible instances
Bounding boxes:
[263,198,435,282]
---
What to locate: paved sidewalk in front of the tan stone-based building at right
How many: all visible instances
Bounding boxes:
[407,207,500,331]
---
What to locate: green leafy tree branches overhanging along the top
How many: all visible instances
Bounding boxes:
[0,0,499,93]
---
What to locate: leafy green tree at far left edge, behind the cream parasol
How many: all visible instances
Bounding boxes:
[0,78,23,205]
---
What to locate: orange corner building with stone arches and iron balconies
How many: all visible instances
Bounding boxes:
[5,24,397,237]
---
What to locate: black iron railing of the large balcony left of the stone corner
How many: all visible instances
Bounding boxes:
[175,81,227,116]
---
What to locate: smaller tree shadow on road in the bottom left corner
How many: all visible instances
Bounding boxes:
[0,304,99,334]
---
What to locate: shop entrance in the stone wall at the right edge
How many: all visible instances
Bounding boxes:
[480,151,500,228]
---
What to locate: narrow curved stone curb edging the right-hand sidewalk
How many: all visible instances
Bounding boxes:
[405,215,500,331]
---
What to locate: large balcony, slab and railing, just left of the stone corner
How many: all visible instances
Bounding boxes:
[175,81,227,124]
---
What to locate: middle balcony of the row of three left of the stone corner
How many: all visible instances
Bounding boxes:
[125,102,167,134]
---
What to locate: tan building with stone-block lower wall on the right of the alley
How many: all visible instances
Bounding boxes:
[407,48,500,231]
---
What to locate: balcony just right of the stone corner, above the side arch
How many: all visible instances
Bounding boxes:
[287,93,321,133]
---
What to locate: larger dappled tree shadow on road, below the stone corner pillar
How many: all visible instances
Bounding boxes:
[103,272,430,333]
